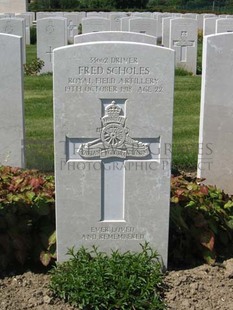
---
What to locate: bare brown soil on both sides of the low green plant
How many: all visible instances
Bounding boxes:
[0,259,233,310]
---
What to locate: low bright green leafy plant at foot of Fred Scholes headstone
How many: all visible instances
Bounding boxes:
[50,243,165,310]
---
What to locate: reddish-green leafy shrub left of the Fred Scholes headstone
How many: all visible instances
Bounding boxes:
[0,167,56,269]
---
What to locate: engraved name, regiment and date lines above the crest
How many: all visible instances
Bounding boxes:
[65,57,163,93]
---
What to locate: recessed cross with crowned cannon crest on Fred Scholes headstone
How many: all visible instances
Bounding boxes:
[66,99,160,222]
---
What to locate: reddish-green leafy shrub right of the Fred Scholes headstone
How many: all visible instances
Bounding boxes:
[169,175,233,265]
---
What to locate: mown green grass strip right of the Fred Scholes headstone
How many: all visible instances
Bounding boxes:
[172,76,201,170]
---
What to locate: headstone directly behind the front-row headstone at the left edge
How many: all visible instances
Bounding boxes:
[0,17,26,63]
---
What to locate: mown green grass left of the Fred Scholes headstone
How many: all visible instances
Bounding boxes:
[24,45,53,171]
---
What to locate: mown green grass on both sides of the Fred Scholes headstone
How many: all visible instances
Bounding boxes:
[24,45,201,171]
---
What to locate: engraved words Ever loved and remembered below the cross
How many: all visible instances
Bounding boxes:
[81,226,144,240]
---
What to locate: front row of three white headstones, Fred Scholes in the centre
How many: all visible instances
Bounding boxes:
[0,29,233,265]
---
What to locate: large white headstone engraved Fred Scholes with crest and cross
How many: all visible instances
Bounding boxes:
[54,41,174,265]
